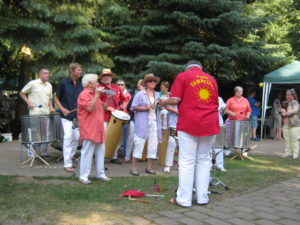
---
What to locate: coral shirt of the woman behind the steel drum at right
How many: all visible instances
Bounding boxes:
[226,96,251,120]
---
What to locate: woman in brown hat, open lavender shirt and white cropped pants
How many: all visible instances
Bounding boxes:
[130,73,162,176]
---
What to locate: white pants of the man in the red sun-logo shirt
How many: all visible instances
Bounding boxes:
[176,131,215,207]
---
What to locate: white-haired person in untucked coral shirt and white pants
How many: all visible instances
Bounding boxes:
[77,74,112,184]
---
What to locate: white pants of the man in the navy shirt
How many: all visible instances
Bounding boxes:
[61,118,79,168]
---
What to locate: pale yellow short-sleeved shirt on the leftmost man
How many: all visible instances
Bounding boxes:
[21,79,52,115]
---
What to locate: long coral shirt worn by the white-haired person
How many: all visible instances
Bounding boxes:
[77,88,105,143]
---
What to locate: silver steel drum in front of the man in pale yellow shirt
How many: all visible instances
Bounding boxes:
[20,115,56,144]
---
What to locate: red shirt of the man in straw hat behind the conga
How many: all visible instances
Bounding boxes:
[99,84,127,122]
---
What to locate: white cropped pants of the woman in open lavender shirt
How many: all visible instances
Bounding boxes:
[132,120,158,159]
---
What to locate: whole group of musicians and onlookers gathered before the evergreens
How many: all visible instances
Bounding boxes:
[20,60,300,207]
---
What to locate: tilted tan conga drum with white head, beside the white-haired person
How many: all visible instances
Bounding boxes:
[105,110,130,158]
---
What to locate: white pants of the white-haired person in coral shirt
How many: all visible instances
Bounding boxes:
[79,140,106,180]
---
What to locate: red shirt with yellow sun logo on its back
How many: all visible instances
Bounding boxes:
[170,67,220,137]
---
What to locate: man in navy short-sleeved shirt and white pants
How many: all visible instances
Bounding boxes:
[54,63,83,172]
